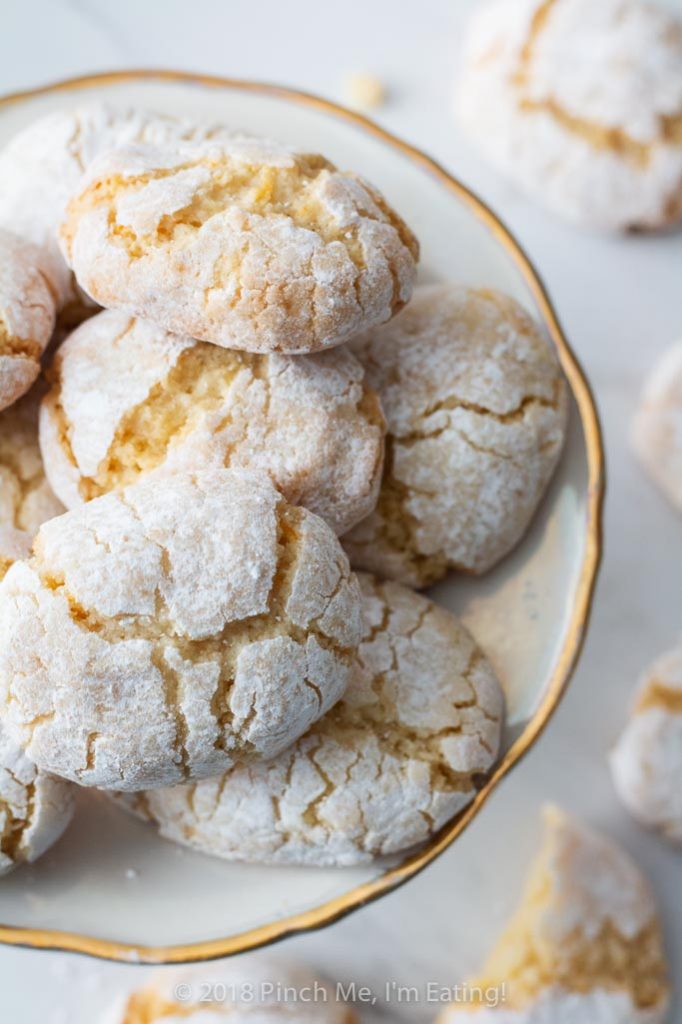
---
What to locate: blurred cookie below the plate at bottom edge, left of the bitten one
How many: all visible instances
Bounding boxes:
[102,956,357,1024]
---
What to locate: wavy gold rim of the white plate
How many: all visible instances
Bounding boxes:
[0,70,605,964]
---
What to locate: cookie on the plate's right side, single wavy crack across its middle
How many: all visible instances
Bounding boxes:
[344,285,567,587]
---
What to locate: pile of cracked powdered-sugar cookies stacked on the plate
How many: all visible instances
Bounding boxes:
[0,105,567,869]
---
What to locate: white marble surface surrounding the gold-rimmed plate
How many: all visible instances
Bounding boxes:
[0,0,682,1024]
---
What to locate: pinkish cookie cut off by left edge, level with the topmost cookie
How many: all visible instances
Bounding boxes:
[0,228,55,410]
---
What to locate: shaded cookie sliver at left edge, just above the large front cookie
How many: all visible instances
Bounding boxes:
[0,389,63,538]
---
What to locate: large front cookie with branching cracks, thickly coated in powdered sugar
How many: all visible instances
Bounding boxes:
[0,469,361,790]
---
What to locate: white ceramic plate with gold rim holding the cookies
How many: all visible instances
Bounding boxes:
[0,72,603,962]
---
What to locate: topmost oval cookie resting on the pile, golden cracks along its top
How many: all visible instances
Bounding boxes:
[60,137,418,353]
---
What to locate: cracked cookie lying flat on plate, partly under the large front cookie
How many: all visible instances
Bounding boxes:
[112,575,504,866]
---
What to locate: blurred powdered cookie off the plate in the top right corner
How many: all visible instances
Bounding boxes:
[457,0,682,230]
